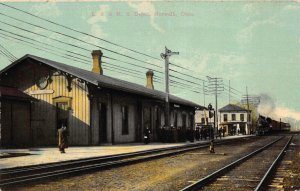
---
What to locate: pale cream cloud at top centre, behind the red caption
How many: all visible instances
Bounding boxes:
[128,0,165,33]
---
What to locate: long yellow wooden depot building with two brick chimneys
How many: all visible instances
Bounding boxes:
[0,50,201,147]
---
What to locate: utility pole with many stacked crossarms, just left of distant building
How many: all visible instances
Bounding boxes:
[206,76,224,134]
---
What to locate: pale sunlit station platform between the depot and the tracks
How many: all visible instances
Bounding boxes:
[0,135,253,170]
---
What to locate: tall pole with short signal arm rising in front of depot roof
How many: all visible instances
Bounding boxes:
[160,47,179,127]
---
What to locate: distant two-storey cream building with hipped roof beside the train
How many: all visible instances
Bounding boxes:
[219,104,251,135]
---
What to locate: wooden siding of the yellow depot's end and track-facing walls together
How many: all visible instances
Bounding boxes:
[1,63,197,146]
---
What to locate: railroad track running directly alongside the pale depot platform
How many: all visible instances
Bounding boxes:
[0,139,244,187]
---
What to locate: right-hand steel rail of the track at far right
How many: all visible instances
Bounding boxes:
[255,136,293,191]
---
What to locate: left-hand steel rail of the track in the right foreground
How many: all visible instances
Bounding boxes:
[180,137,283,191]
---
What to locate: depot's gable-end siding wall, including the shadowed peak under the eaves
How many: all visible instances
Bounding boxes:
[0,60,90,146]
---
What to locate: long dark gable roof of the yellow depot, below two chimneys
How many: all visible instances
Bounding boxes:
[0,54,202,107]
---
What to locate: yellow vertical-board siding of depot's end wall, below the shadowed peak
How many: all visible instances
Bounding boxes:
[25,73,90,145]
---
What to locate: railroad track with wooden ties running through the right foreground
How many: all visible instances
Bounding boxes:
[181,137,292,191]
